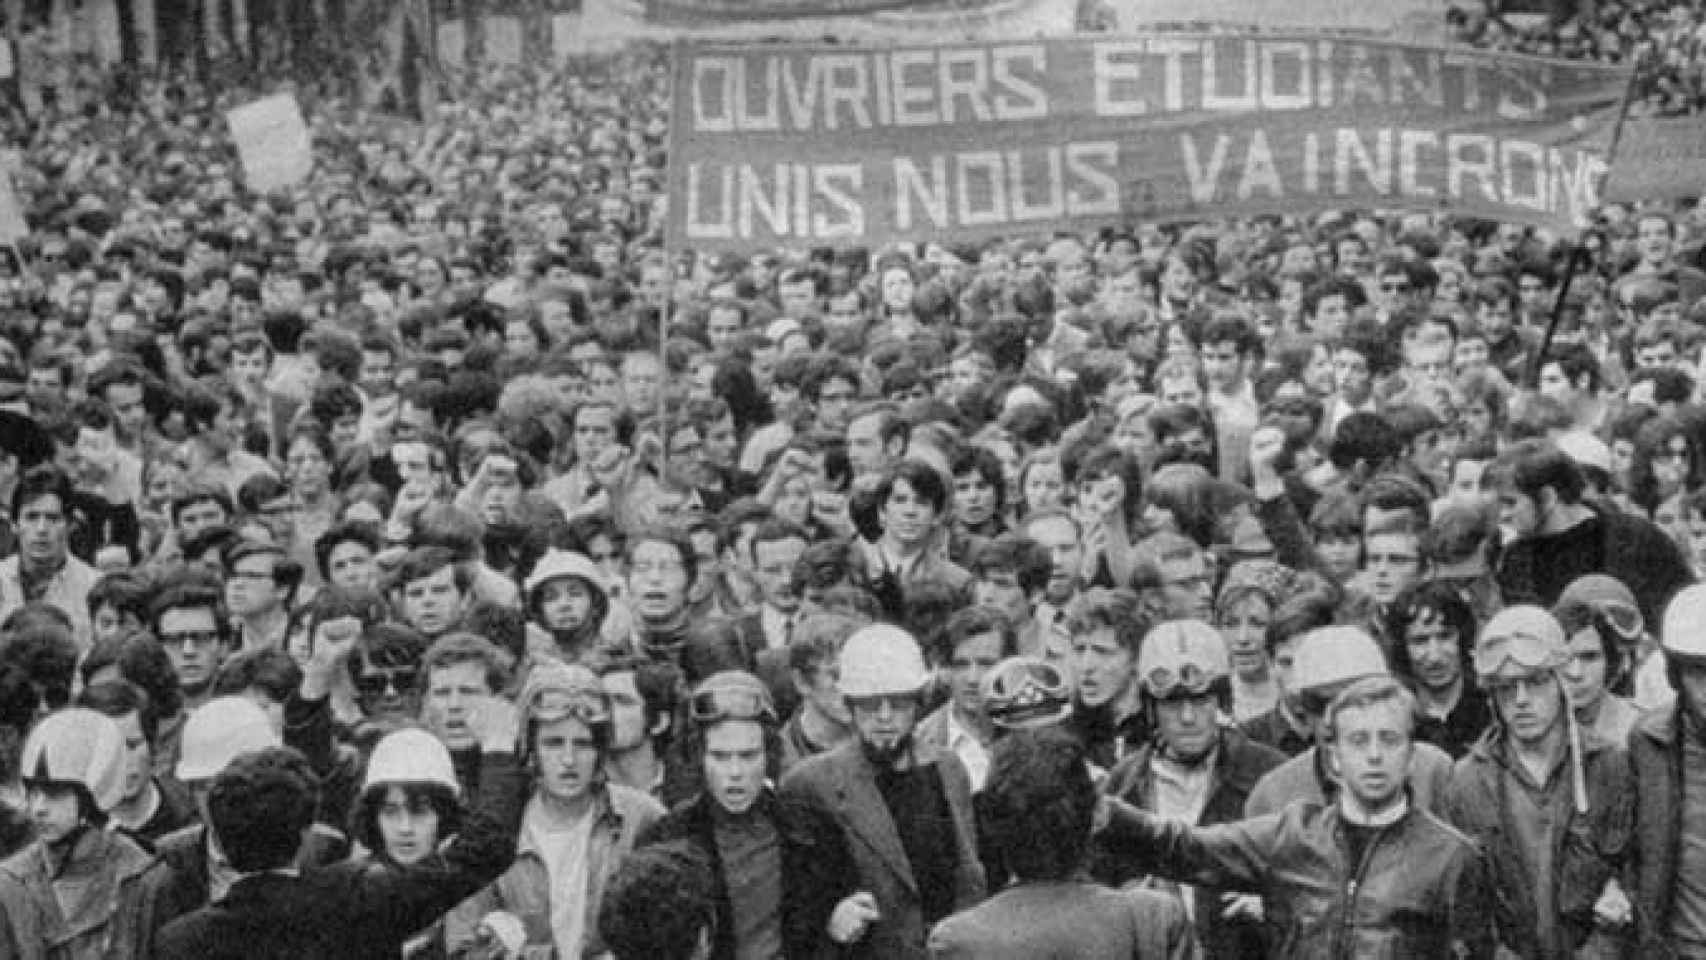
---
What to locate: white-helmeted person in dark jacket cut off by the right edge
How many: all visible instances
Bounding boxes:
[1629,583,1706,957]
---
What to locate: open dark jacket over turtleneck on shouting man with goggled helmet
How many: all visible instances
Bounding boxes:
[638,791,856,960]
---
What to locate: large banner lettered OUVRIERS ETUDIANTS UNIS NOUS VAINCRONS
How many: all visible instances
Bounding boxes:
[667,34,1631,251]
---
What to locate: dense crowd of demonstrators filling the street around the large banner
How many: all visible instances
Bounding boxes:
[0,3,1706,960]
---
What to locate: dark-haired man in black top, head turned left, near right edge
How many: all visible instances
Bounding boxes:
[1483,440,1694,624]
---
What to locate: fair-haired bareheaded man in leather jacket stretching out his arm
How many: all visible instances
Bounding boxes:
[1100,677,1493,960]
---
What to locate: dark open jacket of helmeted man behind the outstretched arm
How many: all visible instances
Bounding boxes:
[1090,730,1286,960]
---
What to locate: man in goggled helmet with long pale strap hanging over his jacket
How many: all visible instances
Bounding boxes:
[1440,605,1631,960]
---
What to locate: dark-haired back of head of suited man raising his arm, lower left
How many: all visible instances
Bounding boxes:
[208,747,319,873]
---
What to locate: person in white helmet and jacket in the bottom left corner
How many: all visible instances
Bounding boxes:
[0,708,160,960]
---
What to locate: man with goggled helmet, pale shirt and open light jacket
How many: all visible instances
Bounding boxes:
[445,660,664,957]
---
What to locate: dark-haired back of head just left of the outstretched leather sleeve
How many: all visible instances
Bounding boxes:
[979,726,1095,880]
